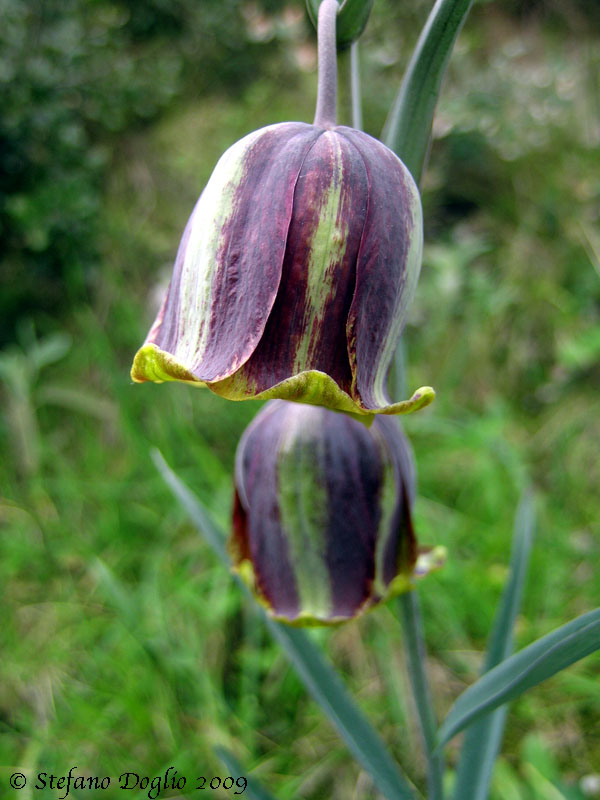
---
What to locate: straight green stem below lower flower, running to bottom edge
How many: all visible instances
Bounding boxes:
[399,590,444,800]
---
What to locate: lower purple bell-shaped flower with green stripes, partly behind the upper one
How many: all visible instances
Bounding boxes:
[230,400,439,625]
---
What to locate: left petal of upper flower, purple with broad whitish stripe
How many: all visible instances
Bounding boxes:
[132,123,320,383]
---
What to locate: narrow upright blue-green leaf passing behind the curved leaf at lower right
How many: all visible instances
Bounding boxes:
[454,490,535,800]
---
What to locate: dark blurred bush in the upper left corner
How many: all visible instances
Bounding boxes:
[0,0,292,343]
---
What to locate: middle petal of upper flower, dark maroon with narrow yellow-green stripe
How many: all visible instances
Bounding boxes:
[213,131,368,396]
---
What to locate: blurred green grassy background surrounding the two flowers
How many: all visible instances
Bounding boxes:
[0,0,600,800]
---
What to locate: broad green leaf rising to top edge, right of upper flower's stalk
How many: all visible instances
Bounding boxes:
[381,0,473,183]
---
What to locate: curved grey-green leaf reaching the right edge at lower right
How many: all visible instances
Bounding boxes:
[438,608,600,747]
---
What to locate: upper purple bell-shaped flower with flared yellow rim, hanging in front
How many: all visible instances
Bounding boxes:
[131,3,433,417]
